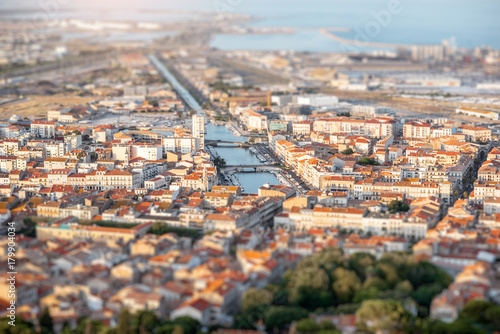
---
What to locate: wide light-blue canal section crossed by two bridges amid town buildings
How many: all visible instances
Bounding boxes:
[205,123,280,193]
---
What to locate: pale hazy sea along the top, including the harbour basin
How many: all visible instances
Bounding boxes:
[0,0,500,52]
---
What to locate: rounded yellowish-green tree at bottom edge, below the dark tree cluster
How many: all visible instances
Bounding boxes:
[356,300,409,333]
